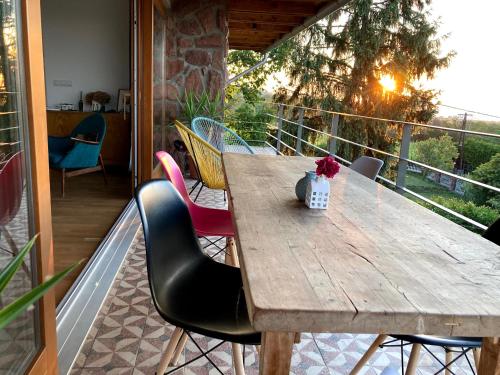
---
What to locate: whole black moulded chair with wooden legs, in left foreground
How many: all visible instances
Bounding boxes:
[135,180,261,375]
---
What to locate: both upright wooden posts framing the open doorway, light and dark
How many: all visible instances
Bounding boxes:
[21,0,156,375]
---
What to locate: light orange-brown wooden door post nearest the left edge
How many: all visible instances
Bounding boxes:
[21,0,58,375]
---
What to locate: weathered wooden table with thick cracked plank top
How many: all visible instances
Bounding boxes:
[223,154,500,375]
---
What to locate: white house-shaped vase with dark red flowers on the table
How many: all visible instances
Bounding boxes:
[305,156,340,210]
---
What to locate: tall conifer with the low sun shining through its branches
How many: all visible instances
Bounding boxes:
[270,0,453,159]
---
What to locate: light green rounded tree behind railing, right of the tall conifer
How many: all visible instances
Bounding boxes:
[410,135,458,173]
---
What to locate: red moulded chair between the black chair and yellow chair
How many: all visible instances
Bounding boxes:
[156,151,234,256]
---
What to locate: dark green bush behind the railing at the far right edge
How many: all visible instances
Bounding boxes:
[466,153,500,210]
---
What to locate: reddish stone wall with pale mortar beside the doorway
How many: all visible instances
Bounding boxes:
[154,0,228,155]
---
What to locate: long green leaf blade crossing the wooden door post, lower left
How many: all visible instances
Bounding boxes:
[0,260,83,329]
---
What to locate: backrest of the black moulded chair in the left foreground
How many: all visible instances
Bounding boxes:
[135,180,205,310]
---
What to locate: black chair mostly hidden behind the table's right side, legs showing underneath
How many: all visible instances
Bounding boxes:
[350,218,500,375]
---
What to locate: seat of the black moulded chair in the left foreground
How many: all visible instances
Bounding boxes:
[154,257,261,345]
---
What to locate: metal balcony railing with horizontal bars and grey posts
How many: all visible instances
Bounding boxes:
[229,103,500,230]
